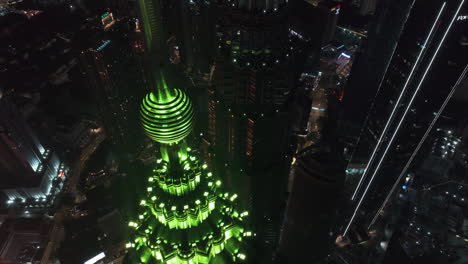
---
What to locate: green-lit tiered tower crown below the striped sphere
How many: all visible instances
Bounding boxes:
[129,146,252,264]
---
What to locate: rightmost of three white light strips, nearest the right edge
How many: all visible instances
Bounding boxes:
[367,65,468,229]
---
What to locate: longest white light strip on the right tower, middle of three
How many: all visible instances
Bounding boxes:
[343,0,465,236]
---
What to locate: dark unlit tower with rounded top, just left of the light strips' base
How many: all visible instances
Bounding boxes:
[278,146,344,263]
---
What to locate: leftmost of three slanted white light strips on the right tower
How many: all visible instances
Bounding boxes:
[351,2,446,201]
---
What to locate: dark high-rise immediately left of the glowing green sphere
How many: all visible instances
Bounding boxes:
[79,16,144,151]
